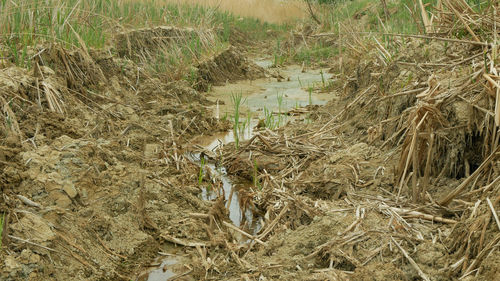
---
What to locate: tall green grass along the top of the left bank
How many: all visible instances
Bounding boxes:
[0,0,290,69]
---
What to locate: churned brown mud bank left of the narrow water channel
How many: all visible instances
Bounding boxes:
[0,32,236,280]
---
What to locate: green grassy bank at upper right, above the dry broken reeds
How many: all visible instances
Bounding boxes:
[290,0,492,65]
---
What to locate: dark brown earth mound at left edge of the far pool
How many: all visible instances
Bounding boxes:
[196,47,266,91]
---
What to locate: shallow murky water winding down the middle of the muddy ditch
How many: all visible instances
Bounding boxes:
[140,59,331,281]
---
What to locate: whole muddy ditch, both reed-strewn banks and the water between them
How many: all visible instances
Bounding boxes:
[0,19,500,281]
